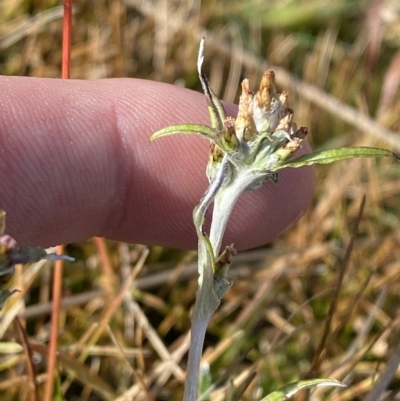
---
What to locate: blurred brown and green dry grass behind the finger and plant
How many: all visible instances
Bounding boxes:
[0,0,400,401]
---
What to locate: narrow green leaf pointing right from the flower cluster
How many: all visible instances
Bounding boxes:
[276,147,400,170]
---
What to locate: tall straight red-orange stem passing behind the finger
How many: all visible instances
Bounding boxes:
[43,0,72,401]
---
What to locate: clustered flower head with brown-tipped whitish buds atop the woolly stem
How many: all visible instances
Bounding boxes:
[200,62,307,189]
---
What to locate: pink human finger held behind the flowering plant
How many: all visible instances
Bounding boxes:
[0,77,314,249]
